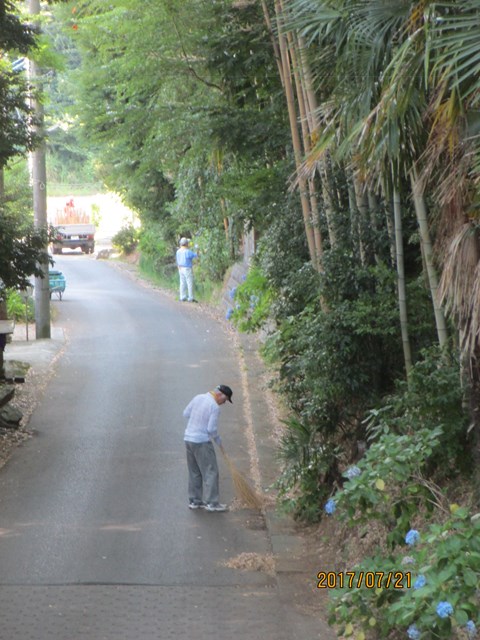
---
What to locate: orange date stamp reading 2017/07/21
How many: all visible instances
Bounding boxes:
[317,571,412,589]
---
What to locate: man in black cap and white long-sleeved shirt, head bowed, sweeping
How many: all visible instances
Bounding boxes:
[183,384,233,511]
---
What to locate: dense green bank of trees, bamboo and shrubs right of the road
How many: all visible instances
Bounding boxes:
[1,0,480,640]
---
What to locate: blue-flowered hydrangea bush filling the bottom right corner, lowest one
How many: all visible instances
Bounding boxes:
[330,500,480,640]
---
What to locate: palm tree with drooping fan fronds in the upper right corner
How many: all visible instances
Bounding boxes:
[291,0,480,470]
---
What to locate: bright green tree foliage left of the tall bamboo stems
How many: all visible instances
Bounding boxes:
[61,0,285,260]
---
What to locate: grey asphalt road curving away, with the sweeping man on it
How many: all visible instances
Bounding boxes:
[0,254,308,640]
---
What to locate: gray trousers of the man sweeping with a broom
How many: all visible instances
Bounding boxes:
[185,442,219,503]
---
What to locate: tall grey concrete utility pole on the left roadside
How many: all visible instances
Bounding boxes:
[29,0,51,339]
